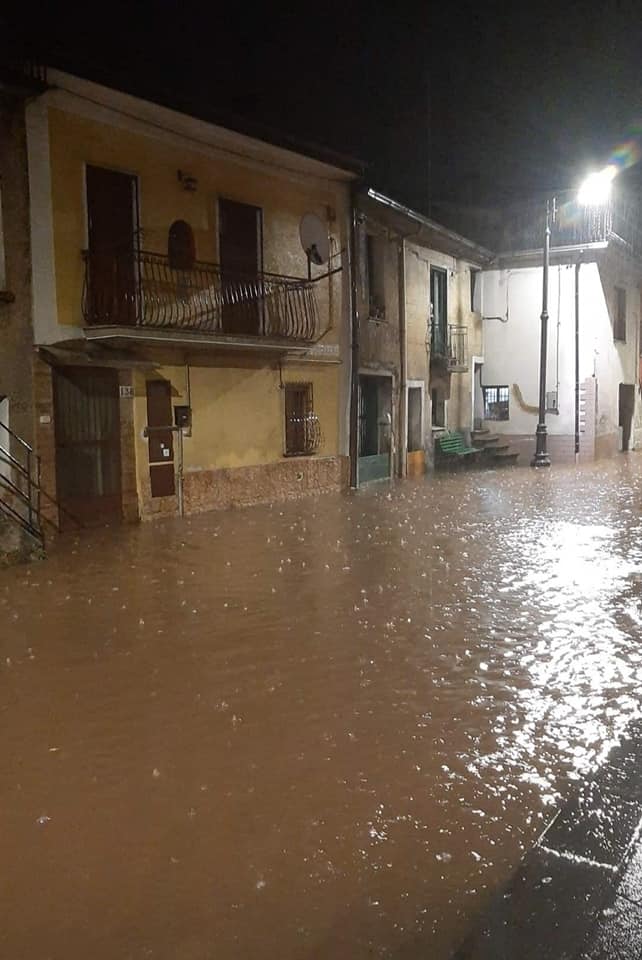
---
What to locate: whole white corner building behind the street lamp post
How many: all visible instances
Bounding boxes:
[475,197,642,464]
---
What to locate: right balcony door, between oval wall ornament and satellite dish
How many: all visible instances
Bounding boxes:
[219,200,262,335]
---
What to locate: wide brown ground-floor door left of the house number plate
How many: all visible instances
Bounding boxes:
[53,367,122,526]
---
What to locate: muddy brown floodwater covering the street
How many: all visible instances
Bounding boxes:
[0,455,642,960]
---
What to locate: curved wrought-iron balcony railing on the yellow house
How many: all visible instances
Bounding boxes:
[82,250,322,342]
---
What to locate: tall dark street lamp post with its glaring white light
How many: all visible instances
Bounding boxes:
[531,164,618,467]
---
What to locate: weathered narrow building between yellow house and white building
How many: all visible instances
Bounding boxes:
[353,190,492,482]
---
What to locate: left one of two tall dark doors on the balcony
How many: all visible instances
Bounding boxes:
[87,166,136,325]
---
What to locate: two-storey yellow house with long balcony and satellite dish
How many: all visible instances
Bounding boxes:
[26,71,354,522]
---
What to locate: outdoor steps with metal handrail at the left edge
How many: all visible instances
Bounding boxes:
[0,423,70,566]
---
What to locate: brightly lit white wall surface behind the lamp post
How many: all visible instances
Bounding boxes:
[482,263,639,444]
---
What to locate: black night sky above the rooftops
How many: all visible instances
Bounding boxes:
[5,0,642,212]
